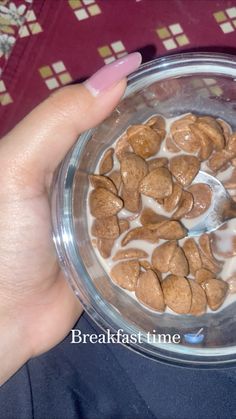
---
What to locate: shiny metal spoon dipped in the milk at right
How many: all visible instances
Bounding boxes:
[188,171,236,237]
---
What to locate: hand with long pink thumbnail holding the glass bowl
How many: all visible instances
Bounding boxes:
[0,50,140,384]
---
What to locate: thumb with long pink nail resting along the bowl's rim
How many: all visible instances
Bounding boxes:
[0,53,141,192]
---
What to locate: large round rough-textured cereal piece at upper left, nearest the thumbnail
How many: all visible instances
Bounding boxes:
[127,125,163,159]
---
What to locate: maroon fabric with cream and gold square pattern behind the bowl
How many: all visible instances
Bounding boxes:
[0,0,236,135]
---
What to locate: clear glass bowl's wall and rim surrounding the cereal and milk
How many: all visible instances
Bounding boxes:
[52,53,236,367]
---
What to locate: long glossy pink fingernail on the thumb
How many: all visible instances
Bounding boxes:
[84,52,142,96]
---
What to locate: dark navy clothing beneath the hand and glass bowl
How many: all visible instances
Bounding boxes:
[0,314,236,419]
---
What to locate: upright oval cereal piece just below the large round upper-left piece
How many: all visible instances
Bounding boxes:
[120,153,148,191]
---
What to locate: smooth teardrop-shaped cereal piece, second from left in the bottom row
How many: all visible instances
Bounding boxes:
[135,270,165,312]
